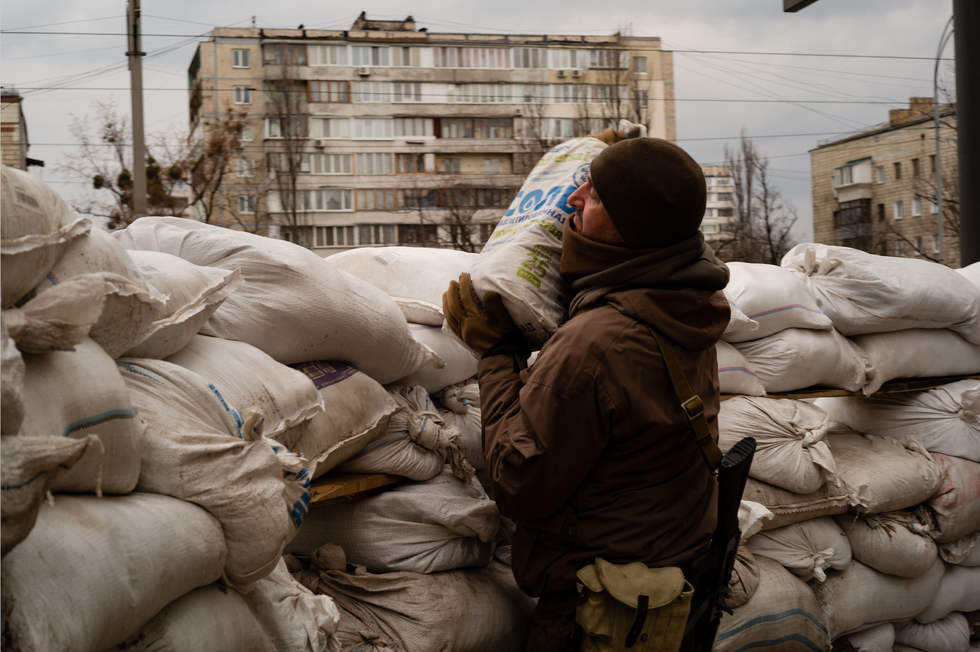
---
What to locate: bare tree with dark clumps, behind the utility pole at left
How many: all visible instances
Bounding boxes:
[58,101,186,228]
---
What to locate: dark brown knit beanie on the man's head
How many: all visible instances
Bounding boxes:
[592,138,708,249]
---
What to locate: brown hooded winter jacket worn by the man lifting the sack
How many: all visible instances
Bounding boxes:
[479,288,730,596]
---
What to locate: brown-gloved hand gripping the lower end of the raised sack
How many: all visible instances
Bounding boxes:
[442,273,517,356]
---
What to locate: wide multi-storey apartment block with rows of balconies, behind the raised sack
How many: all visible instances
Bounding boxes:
[188,13,675,256]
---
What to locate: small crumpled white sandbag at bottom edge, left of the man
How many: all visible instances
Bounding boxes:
[245,559,340,652]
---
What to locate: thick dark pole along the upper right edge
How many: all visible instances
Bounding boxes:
[953,0,980,267]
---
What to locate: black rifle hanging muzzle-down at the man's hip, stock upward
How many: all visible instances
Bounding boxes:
[684,437,755,652]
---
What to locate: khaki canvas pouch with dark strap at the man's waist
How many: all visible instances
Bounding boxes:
[575,557,694,652]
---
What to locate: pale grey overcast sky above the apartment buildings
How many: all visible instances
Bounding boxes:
[0,0,953,241]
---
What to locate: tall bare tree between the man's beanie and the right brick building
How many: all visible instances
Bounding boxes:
[712,134,797,265]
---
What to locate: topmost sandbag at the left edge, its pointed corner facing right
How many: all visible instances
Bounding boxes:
[0,165,92,308]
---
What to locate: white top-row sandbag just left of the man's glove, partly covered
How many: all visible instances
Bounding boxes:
[326,247,478,326]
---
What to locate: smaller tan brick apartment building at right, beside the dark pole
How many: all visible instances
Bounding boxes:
[810,97,960,267]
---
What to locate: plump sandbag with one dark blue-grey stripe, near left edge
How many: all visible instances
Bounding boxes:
[20,338,146,494]
